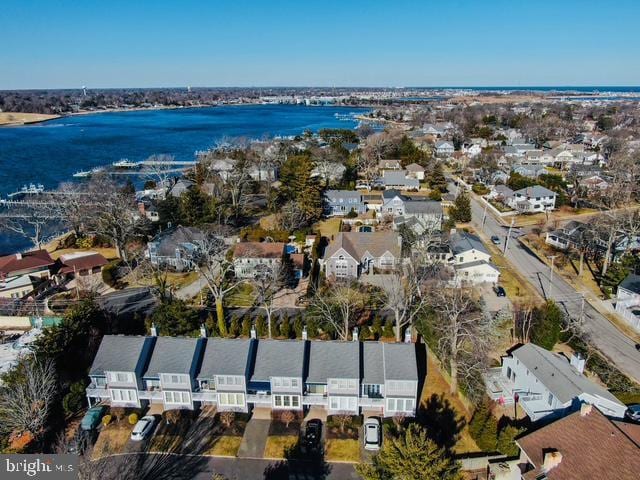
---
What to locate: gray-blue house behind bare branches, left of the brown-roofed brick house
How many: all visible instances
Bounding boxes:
[145,225,205,272]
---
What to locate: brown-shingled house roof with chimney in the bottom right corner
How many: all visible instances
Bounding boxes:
[516,404,640,480]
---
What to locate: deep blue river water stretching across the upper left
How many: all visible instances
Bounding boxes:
[0,105,367,252]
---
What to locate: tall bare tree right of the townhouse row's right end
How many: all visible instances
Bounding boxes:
[429,284,497,393]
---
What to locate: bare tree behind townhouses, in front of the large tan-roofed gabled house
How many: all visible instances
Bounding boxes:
[311,282,365,340]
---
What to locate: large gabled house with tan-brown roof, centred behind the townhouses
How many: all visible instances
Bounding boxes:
[322,232,402,278]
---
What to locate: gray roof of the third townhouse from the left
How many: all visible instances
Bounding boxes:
[198,338,252,379]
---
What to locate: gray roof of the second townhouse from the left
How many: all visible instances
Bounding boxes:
[143,337,202,378]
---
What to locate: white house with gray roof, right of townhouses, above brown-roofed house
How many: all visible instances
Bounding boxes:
[486,343,627,422]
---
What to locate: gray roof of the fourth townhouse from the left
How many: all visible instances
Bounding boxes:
[251,340,305,382]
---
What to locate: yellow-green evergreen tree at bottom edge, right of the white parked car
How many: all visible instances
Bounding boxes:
[356,423,463,480]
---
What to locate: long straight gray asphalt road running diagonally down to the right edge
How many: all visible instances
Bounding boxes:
[462,187,640,382]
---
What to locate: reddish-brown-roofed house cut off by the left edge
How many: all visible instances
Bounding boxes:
[0,250,55,299]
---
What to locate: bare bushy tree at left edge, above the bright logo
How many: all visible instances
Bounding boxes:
[0,358,57,438]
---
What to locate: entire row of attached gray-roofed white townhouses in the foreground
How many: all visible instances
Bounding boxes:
[86,335,418,416]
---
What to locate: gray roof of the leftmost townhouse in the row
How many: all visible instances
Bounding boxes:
[89,335,153,375]
